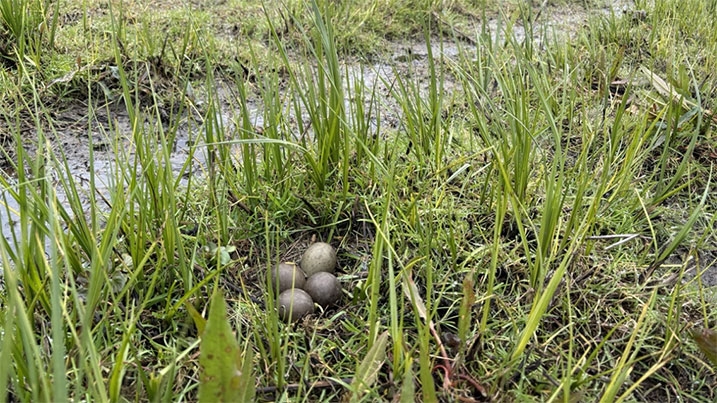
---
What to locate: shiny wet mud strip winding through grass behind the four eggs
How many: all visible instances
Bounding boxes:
[3,0,634,207]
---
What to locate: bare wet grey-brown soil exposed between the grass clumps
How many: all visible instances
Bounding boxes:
[5,0,717,287]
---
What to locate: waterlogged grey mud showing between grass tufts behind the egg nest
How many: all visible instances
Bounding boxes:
[5,1,717,286]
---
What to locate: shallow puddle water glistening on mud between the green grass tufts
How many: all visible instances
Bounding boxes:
[11,1,717,292]
